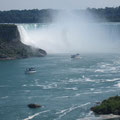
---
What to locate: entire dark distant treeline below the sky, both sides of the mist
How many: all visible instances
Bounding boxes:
[0,7,120,23]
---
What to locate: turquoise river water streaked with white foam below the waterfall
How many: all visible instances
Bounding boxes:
[0,54,120,120]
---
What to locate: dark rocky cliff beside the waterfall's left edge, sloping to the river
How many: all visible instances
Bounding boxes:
[0,24,47,59]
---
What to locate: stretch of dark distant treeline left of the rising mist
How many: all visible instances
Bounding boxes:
[0,9,55,23]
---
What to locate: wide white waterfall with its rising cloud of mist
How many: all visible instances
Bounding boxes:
[18,11,120,53]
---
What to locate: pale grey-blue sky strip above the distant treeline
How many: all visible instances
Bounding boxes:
[0,0,120,10]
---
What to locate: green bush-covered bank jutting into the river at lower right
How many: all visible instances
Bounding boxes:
[91,96,120,115]
